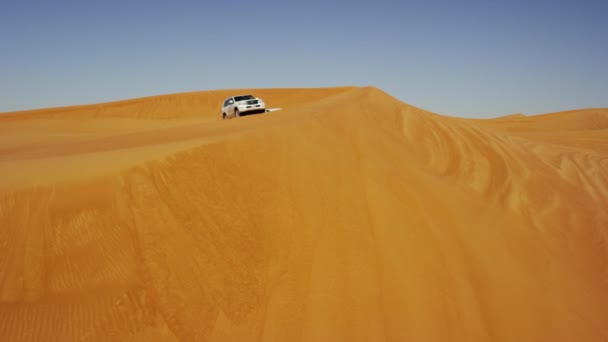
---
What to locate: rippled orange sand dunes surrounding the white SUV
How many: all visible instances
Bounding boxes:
[0,87,608,341]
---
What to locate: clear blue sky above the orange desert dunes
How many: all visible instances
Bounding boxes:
[0,0,608,117]
